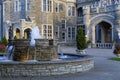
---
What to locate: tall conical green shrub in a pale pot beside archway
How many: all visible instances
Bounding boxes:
[76,28,86,54]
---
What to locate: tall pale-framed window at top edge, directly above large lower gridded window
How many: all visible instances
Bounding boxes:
[42,0,53,12]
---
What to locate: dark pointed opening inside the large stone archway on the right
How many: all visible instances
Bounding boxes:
[95,21,112,43]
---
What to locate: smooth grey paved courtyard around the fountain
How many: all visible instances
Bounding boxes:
[0,47,120,80]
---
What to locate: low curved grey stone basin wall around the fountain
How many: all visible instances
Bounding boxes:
[0,54,94,77]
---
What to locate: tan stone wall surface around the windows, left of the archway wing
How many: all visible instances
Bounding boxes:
[7,0,77,44]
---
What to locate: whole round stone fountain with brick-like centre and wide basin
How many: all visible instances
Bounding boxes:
[0,28,94,77]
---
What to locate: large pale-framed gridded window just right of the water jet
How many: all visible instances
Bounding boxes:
[42,25,53,39]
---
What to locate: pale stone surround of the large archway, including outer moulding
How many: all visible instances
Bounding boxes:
[87,14,115,44]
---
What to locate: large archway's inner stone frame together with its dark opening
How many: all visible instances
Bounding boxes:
[90,20,113,44]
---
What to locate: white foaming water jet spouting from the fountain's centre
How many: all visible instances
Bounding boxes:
[30,26,42,46]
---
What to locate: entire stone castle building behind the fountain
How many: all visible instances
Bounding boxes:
[2,0,120,47]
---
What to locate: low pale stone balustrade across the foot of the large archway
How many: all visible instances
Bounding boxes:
[92,43,113,49]
